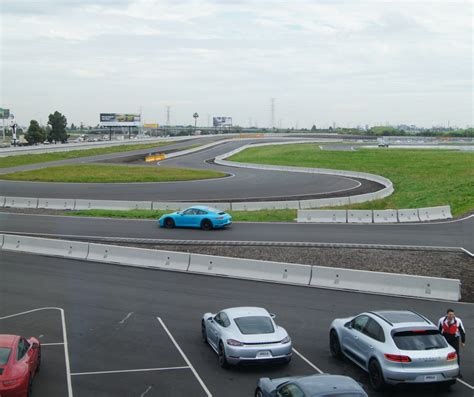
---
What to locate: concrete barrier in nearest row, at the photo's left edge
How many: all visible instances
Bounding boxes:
[2,234,89,259]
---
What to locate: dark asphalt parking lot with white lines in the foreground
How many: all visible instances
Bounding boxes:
[0,251,474,397]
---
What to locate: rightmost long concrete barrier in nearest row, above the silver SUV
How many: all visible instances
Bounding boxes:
[310,266,461,301]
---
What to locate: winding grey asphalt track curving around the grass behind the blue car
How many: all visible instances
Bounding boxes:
[0,138,382,201]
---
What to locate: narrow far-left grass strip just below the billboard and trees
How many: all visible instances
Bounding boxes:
[0,142,177,168]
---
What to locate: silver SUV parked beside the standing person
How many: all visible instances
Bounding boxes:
[329,310,459,390]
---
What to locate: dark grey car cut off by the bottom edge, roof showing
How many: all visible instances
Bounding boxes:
[255,374,367,397]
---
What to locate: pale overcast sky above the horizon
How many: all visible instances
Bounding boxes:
[0,0,474,128]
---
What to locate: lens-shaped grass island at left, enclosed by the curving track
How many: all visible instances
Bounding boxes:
[0,164,227,183]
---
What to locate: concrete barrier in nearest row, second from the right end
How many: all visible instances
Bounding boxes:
[189,254,311,285]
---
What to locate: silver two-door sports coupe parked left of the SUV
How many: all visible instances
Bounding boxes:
[201,307,292,368]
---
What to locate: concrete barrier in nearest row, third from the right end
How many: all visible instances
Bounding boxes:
[87,243,190,271]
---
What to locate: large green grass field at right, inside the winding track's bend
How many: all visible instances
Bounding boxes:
[229,144,474,216]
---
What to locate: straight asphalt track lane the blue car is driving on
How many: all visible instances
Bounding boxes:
[0,212,474,253]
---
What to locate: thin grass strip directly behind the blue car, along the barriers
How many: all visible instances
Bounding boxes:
[67,209,296,222]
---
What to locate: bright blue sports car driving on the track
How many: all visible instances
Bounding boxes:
[158,206,232,230]
